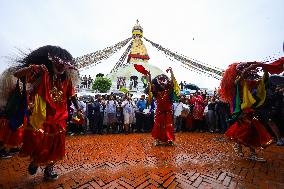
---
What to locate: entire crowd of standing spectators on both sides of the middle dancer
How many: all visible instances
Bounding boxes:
[69,87,283,139]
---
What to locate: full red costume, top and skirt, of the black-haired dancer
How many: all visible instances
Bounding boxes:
[22,67,75,164]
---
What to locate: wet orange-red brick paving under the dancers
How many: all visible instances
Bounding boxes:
[0,133,284,189]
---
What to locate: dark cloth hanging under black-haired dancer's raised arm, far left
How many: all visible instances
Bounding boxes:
[5,79,28,131]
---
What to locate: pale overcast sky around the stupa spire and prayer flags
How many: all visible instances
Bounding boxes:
[0,0,284,88]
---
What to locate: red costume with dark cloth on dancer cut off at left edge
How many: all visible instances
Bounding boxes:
[0,76,27,153]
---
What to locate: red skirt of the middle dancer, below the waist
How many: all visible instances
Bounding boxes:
[152,112,175,142]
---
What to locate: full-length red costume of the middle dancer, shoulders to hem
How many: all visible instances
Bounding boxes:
[152,89,175,142]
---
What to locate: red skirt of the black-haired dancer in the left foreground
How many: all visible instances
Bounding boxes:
[21,121,66,165]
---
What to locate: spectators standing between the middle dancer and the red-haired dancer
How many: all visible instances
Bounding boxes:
[174,92,230,133]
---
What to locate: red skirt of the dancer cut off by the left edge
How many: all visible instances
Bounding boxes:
[0,118,25,148]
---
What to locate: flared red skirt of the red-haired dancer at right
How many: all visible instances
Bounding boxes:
[225,118,272,148]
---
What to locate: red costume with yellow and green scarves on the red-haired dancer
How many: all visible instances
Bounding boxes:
[220,58,284,149]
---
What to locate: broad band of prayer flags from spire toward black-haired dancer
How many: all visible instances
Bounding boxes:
[74,37,132,69]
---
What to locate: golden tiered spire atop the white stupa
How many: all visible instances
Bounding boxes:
[127,20,150,63]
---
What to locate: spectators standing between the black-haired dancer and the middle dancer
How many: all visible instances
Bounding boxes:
[68,94,155,135]
